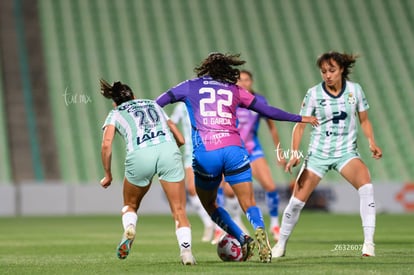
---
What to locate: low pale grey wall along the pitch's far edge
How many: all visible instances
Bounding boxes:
[0,182,414,216]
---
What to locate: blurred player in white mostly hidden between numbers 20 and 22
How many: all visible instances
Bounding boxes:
[170,102,215,242]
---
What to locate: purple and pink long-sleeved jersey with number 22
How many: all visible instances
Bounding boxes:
[157,76,302,151]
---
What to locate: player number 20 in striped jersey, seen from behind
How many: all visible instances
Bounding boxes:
[101,80,195,265]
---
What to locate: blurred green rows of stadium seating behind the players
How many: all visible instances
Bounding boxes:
[38,0,414,183]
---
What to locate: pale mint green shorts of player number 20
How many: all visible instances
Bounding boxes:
[125,142,184,187]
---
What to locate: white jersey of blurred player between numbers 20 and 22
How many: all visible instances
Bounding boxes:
[170,102,193,156]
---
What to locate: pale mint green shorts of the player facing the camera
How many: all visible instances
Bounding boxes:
[302,151,360,178]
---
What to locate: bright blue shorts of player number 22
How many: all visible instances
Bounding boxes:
[193,146,252,190]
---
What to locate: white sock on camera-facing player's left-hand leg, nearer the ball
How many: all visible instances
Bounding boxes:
[277,196,305,247]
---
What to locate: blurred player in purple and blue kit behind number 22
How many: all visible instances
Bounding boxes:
[212,70,286,244]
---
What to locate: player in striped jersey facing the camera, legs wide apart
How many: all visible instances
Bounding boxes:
[272,52,382,258]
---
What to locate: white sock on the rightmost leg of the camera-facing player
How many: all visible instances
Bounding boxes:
[358,183,375,243]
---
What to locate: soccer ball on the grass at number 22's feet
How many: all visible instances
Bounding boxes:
[217,234,243,262]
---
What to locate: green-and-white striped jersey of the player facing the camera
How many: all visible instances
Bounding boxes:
[300,81,369,157]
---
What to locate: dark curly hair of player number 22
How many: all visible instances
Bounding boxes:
[194,53,246,84]
